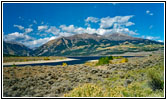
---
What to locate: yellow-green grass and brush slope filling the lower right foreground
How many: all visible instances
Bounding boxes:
[64,62,164,97]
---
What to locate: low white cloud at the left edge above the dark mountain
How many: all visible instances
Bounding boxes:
[4,32,33,43]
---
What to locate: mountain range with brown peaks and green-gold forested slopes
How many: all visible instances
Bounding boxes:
[3,33,163,56]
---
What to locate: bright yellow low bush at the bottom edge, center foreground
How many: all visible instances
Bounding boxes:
[64,84,122,97]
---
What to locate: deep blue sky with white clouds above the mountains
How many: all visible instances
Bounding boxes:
[3,3,164,48]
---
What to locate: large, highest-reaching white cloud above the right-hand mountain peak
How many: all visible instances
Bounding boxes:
[100,15,134,28]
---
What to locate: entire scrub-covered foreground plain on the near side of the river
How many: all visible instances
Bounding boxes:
[3,52,164,97]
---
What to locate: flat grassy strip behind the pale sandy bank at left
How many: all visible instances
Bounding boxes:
[3,56,66,63]
